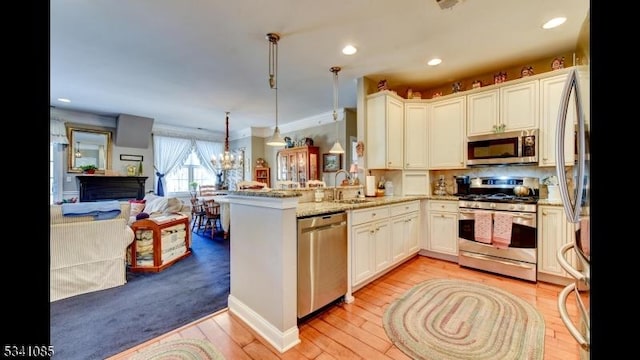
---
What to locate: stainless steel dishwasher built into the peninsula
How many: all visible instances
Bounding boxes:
[298,212,347,318]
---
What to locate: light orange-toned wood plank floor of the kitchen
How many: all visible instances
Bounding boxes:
[109,256,579,360]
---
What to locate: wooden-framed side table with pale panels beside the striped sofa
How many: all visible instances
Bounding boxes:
[127,214,191,272]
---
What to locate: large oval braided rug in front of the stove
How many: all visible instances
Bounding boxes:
[382,279,544,360]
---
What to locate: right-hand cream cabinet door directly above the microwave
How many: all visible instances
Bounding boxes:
[500,80,539,131]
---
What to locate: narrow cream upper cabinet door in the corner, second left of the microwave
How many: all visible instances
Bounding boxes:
[404,103,429,170]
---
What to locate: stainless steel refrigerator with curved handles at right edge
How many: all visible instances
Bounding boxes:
[556,11,591,359]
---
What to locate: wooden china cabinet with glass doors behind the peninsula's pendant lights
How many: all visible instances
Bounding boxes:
[276,146,320,187]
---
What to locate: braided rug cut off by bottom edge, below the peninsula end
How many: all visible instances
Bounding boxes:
[130,339,225,360]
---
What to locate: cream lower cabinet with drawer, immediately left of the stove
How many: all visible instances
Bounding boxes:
[427,200,458,260]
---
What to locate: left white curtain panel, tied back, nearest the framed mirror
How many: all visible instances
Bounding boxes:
[153,135,193,196]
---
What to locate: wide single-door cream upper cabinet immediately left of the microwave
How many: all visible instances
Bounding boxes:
[427,96,466,170]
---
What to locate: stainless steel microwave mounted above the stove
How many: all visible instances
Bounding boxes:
[467,129,540,165]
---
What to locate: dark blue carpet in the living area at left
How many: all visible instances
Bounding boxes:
[50,233,230,360]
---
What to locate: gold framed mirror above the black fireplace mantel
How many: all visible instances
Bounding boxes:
[67,126,112,174]
